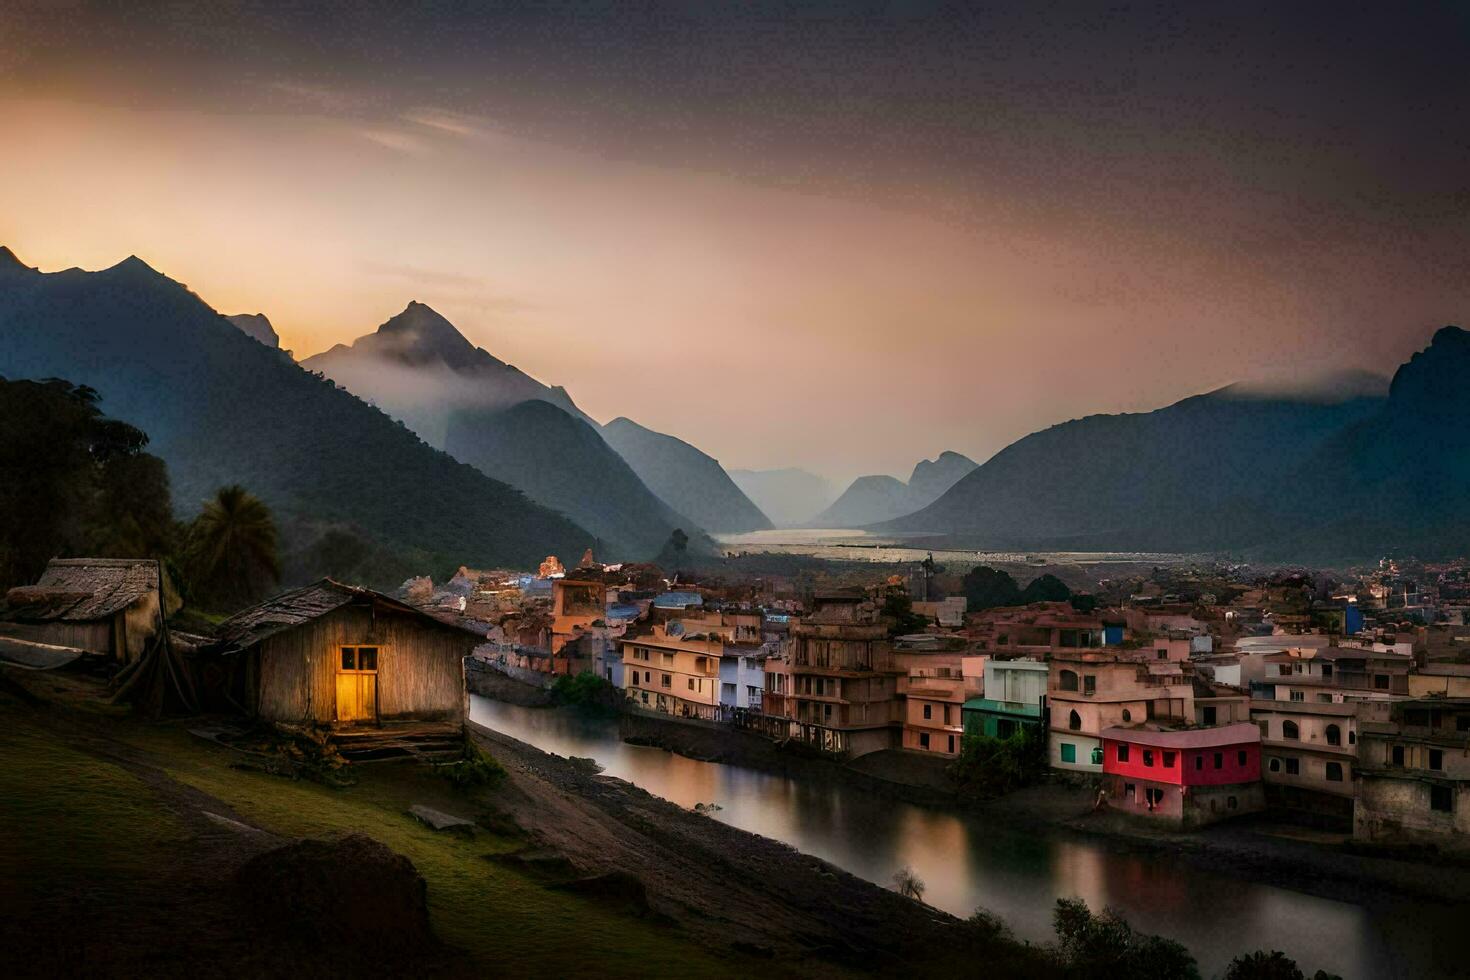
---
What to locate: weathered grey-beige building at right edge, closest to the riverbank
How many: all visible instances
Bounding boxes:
[1352,698,1470,854]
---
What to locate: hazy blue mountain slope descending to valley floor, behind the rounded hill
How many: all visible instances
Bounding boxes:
[603,419,770,533]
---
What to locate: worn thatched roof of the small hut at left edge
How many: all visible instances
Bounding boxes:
[6,558,169,621]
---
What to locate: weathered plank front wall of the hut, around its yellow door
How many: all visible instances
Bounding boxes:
[259,605,478,723]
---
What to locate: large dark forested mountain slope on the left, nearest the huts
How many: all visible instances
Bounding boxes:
[0,253,592,585]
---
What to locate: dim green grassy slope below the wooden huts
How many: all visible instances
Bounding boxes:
[0,681,739,977]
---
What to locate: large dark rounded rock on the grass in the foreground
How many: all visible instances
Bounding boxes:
[235,833,438,964]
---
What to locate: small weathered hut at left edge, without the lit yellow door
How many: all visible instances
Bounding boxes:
[0,558,182,664]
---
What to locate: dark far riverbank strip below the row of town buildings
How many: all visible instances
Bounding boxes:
[619,702,1470,905]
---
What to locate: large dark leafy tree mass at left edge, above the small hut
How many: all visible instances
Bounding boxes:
[0,378,176,586]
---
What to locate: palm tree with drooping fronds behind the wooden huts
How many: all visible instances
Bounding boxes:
[188,483,281,608]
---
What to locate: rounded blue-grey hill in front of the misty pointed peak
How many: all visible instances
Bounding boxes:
[444,400,707,558]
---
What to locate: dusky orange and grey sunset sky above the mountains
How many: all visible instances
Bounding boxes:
[0,0,1470,480]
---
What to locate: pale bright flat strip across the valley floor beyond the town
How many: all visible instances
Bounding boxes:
[714,527,1189,566]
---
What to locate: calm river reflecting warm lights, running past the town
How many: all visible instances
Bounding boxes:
[470,695,1470,980]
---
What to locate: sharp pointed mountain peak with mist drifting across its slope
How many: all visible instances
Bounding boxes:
[301,301,597,450]
